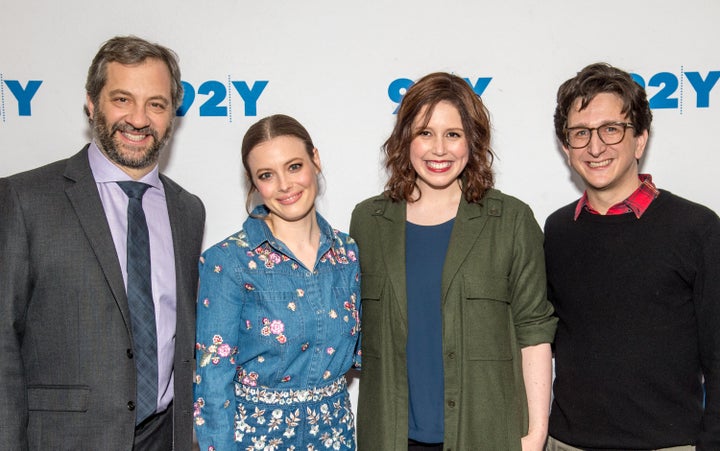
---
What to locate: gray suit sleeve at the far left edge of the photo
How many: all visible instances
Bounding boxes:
[0,179,31,450]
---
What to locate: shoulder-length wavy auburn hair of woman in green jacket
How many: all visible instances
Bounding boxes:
[383,72,494,203]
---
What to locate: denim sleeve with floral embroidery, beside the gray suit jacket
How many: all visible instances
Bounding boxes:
[194,246,244,451]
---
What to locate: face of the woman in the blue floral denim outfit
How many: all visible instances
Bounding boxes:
[247,136,320,226]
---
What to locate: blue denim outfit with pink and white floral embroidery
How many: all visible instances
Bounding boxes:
[194,206,360,451]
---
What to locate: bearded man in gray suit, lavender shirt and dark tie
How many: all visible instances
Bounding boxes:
[0,37,205,450]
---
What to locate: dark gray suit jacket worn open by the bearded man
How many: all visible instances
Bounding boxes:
[0,146,205,450]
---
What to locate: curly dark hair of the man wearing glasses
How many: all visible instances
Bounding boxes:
[555,63,652,145]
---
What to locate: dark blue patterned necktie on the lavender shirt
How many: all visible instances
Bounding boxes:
[117,182,158,424]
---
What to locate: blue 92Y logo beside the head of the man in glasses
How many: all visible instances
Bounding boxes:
[631,66,720,114]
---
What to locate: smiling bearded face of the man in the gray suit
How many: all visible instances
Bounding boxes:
[87,58,174,179]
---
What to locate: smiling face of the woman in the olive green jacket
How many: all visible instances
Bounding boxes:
[410,101,470,197]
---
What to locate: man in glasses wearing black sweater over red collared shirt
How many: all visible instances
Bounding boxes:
[545,63,720,451]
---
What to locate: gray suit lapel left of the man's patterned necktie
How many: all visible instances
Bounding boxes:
[64,146,130,331]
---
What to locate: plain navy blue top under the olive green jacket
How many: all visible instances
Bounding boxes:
[405,219,455,443]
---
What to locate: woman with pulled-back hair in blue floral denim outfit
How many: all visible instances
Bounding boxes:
[194,115,360,451]
